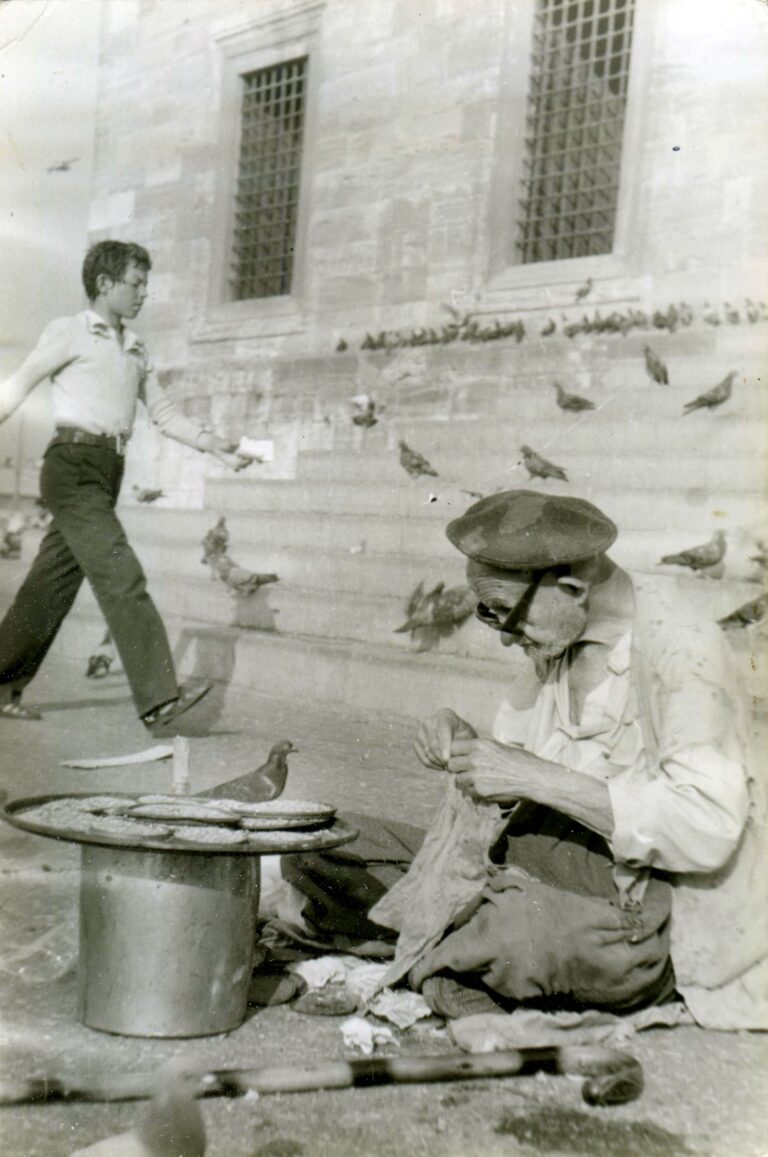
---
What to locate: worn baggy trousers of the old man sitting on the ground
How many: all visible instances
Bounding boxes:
[282,805,674,1010]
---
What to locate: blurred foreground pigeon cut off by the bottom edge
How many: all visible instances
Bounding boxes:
[71,1061,206,1157]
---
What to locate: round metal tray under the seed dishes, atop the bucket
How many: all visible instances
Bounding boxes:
[0,791,357,856]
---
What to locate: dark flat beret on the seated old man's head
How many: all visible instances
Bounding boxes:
[445,491,619,570]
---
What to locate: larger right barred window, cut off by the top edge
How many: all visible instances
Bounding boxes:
[517,0,634,264]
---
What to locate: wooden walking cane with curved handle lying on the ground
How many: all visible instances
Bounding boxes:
[0,1045,643,1105]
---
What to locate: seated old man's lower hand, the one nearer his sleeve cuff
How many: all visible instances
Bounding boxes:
[448,737,562,803]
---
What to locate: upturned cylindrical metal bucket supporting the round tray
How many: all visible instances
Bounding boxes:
[79,846,259,1037]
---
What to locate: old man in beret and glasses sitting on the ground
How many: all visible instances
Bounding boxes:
[278,491,768,1027]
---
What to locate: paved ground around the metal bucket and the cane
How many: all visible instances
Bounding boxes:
[0,643,768,1157]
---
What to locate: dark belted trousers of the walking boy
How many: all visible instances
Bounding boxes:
[0,436,178,715]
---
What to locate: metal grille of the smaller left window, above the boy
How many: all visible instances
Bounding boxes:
[230,57,308,301]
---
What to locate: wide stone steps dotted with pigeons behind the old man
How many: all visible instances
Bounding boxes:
[6,327,768,725]
